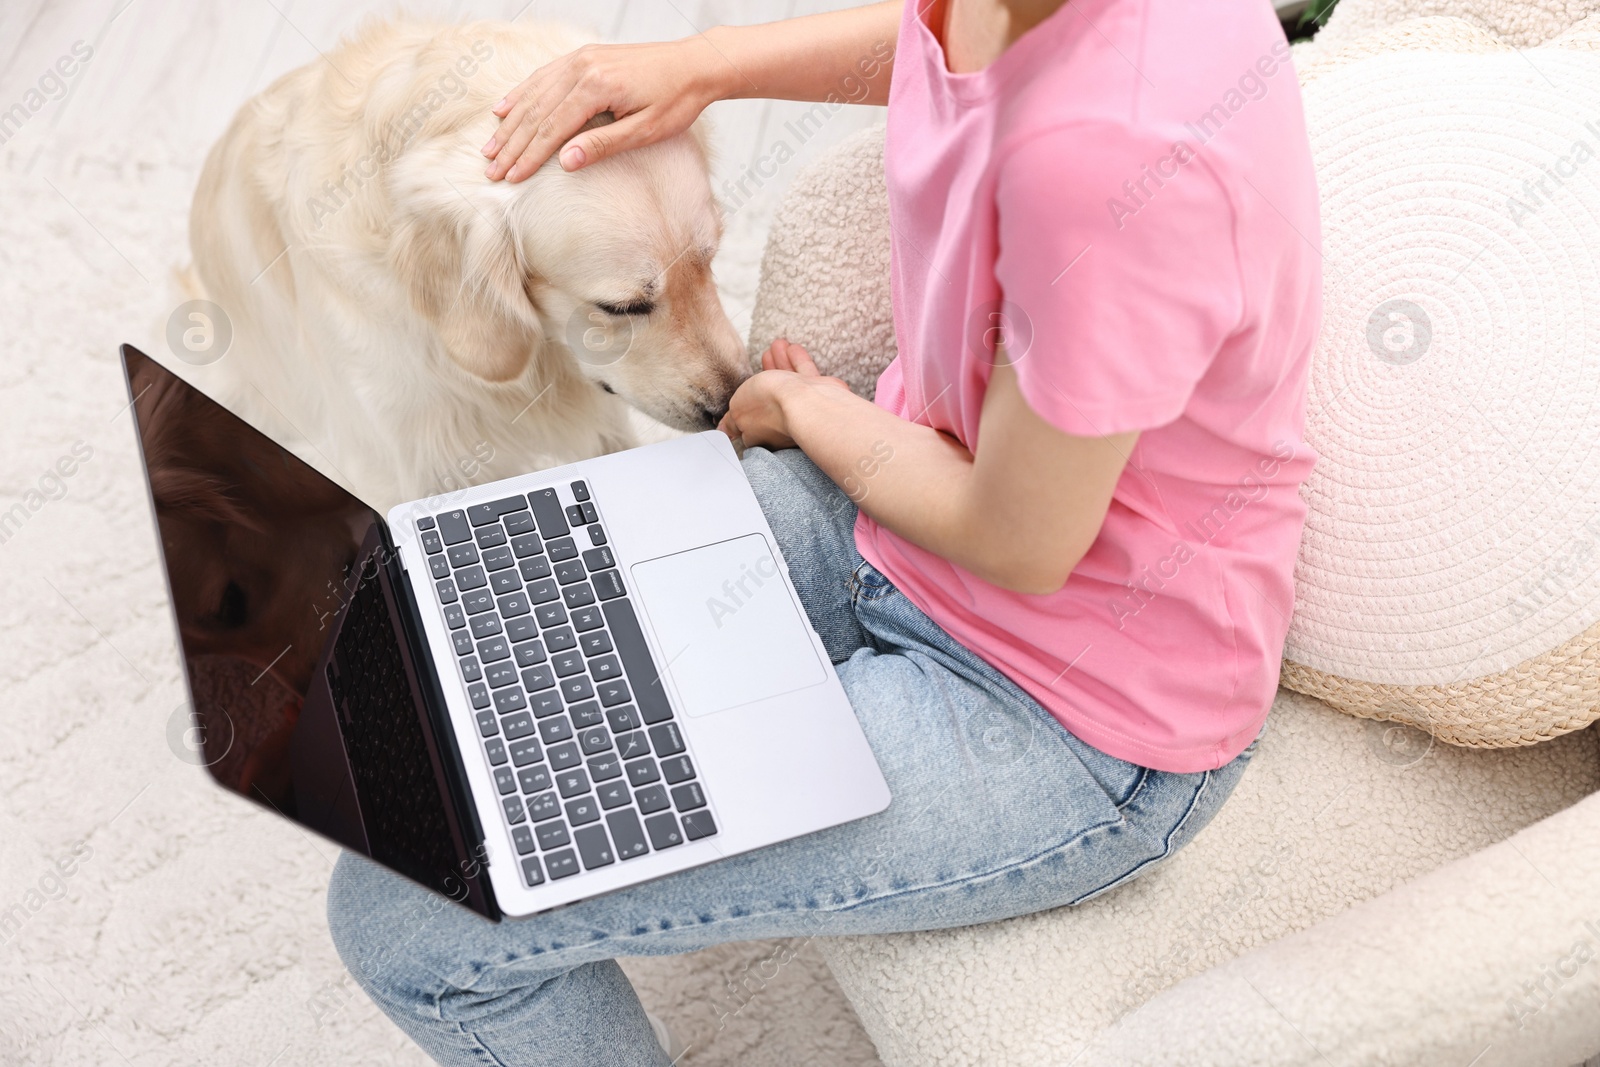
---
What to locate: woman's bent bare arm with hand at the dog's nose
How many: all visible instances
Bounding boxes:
[723,341,1139,593]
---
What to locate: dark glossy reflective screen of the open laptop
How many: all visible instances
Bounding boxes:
[123,347,493,910]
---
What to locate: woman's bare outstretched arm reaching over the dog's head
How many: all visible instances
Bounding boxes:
[483,0,901,182]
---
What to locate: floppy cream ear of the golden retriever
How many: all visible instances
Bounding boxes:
[389,211,544,382]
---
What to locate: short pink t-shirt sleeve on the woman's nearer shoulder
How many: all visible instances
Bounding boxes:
[995,123,1242,437]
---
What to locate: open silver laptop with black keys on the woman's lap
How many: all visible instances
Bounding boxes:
[122,346,890,920]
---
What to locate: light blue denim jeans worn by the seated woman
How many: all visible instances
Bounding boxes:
[328,448,1256,1067]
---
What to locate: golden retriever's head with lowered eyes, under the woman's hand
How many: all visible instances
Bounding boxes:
[389,88,749,430]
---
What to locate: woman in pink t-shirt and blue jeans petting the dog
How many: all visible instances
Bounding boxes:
[328,0,1320,1065]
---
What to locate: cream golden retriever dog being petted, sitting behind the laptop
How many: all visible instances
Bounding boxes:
[190,19,749,509]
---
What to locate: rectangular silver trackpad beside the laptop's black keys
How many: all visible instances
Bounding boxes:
[630,534,827,715]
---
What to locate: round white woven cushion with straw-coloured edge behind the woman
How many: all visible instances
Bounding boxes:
[1283,18,1600,747]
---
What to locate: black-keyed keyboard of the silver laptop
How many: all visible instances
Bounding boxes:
[418,482,717,886]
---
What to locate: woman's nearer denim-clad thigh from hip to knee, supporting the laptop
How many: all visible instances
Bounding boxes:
[328,633,1246,993]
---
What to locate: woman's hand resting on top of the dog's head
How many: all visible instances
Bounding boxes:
[483,37,723,182]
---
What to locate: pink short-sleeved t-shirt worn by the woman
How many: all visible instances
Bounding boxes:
[856,0,1322,771]
